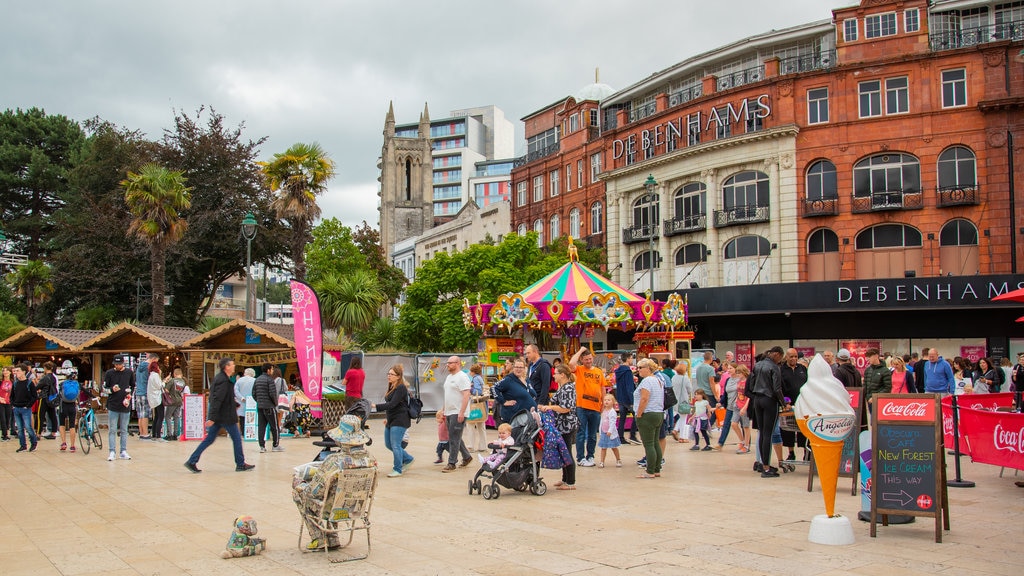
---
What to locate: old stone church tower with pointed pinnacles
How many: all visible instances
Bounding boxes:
[377,102,434,262]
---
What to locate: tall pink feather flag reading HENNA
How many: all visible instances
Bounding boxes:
[291,280,324,418]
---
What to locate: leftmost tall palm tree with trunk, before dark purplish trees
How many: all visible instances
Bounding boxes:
[121,164,191,326]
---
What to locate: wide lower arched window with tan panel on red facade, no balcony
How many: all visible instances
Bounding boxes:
[854,223,923,280]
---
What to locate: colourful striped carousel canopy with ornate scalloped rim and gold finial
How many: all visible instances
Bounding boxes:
[463,238,692,355]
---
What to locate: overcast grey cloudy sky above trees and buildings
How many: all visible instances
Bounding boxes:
[0,0,857,227]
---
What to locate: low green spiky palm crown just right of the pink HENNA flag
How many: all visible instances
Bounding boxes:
[313,270,387,336]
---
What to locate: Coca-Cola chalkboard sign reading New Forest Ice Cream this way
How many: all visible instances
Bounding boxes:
[871,394,949,542]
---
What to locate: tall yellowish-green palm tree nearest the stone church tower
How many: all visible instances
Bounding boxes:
[259,142,335,280]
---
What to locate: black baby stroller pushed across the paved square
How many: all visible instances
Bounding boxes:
[469,411,548,500]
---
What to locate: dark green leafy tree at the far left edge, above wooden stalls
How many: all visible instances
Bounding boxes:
[0,108,85,260]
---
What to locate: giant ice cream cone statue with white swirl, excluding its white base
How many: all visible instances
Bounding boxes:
[793,355,854,518]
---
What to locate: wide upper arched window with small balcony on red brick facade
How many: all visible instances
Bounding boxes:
[853,153,923,207]
